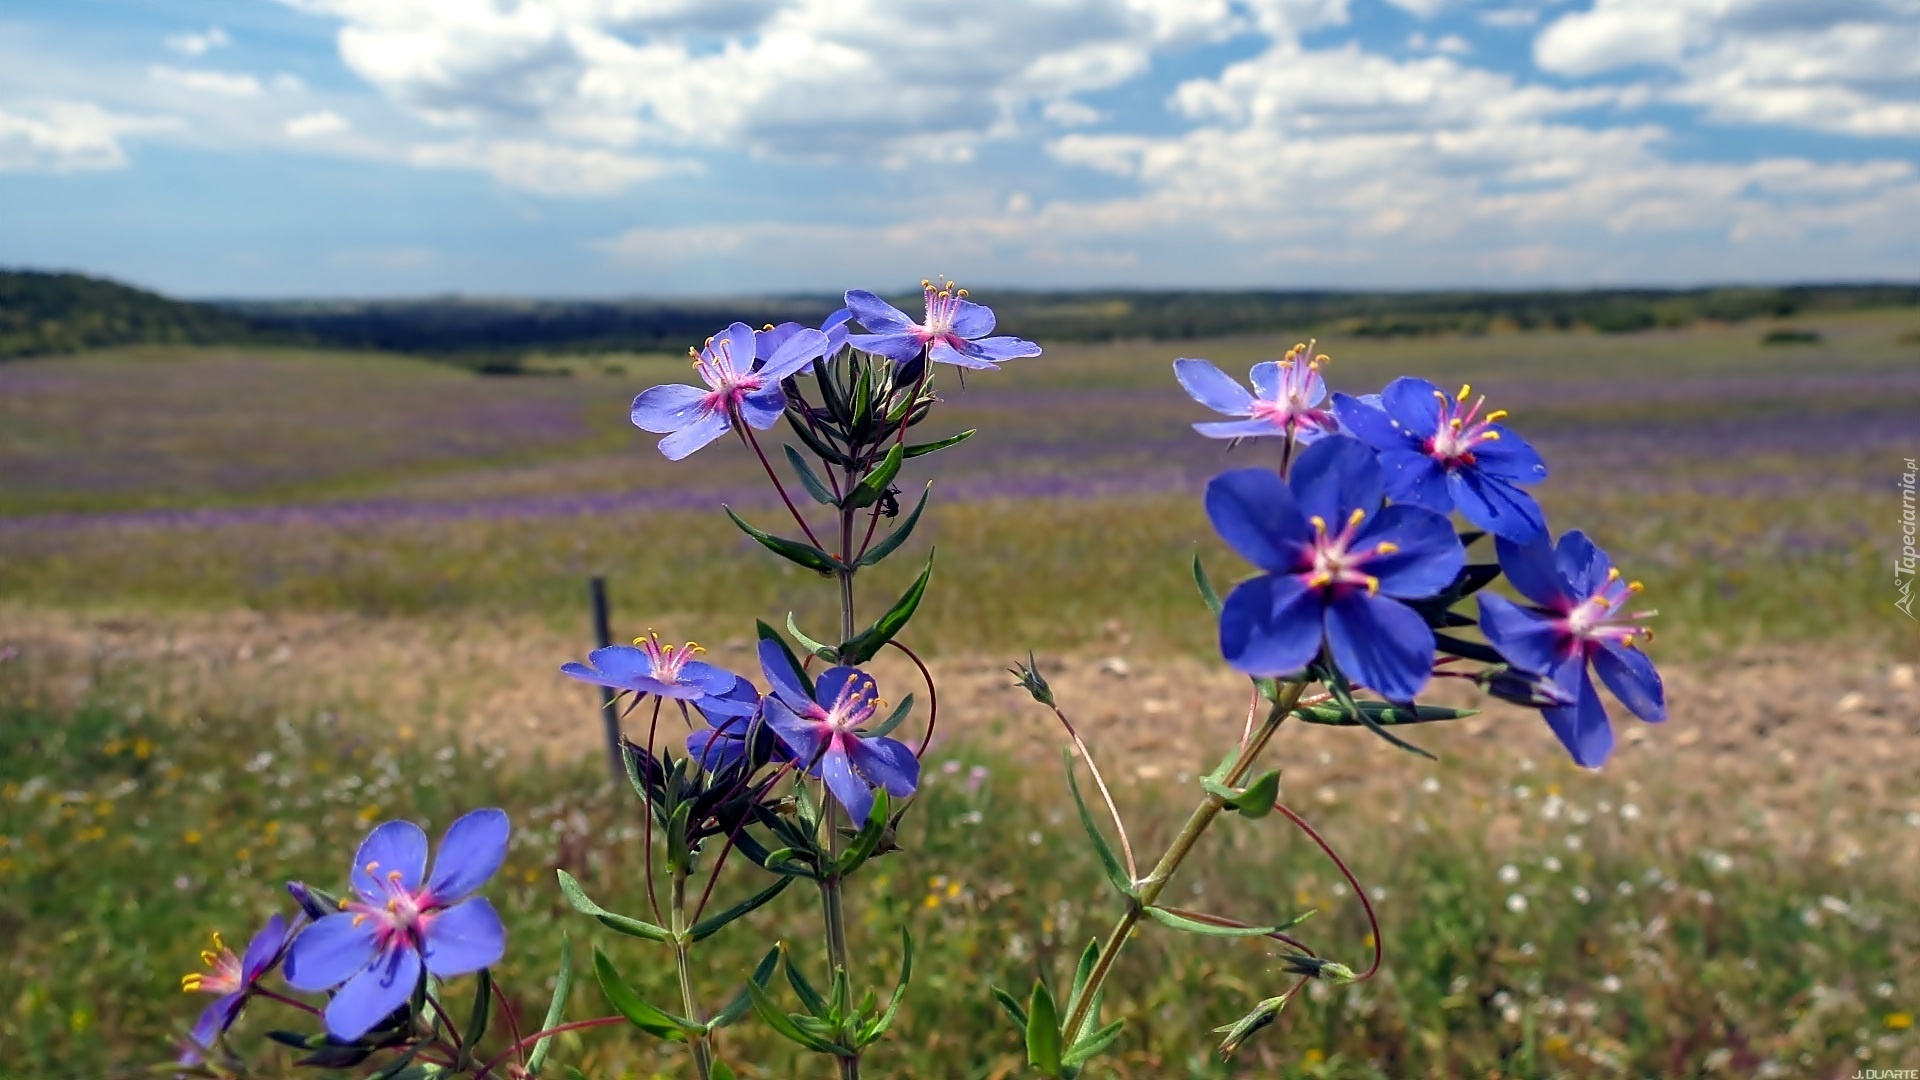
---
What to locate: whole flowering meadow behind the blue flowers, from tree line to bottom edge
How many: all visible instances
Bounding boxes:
[0,309,1920,1078]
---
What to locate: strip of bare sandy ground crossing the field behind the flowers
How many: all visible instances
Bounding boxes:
[0,605,1920,847]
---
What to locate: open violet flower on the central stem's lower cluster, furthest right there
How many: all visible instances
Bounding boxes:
[760,642,920,828]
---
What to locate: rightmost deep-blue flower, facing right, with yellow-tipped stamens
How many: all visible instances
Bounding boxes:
[1480,530,1667,769]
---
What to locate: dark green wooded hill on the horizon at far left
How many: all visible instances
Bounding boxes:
[0,271,255,359]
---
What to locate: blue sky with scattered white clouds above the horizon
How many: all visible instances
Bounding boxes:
[0,0,1920,298]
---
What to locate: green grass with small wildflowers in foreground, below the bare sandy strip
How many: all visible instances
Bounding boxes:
[0,678,1920,1078]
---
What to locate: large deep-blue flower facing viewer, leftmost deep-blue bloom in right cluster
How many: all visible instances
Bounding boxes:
[1206,436,1467,701]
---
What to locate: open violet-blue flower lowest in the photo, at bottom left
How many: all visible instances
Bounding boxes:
[286,809,511,1042]
